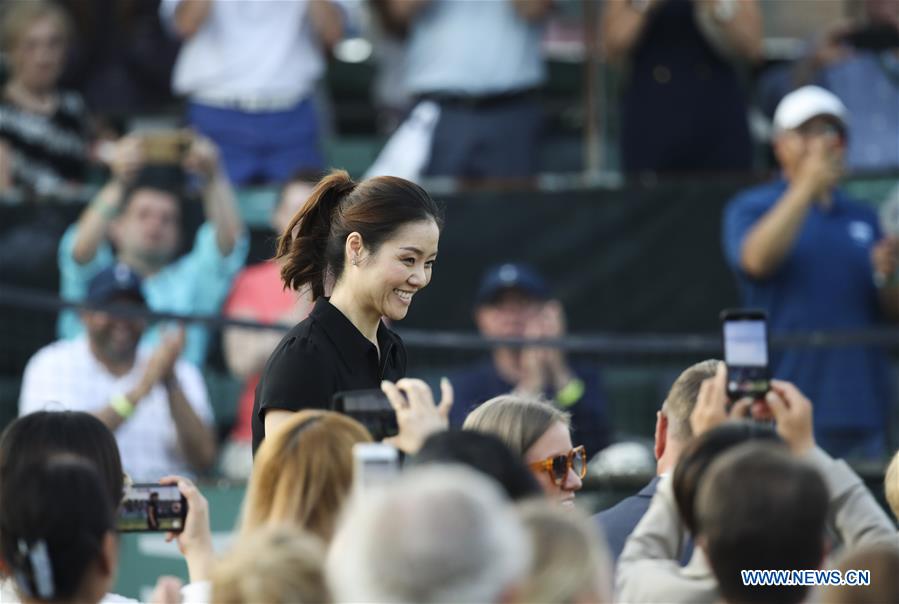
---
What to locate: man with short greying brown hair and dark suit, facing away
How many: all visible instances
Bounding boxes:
[593,360,720,560]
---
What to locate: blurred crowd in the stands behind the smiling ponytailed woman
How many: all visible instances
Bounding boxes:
[0,0,899,598]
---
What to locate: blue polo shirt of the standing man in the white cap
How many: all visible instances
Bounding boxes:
[722,180,893,431]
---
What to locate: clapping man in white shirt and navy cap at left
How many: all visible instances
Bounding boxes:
[19,264,216,481]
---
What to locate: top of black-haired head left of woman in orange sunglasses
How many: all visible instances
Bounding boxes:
[407,430,542,501]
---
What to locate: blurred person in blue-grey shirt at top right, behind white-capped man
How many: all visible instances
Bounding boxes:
[759,0,899,170]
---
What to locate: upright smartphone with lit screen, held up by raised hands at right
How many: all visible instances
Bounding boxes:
[721,309,770,400]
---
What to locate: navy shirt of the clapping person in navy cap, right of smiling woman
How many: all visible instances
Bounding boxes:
[450,359,611,459]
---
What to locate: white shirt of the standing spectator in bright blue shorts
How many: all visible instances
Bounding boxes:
[159,0,325,102]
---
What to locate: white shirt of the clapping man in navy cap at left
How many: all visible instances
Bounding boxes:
[19,336,213,482]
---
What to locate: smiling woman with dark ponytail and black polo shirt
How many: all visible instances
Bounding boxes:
[253,170,443,452]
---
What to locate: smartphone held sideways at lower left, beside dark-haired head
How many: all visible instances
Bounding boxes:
[116,483,187,533]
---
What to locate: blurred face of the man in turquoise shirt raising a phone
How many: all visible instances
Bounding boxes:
[112,189,181,267]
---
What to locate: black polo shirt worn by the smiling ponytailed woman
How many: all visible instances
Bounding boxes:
[253,298,406,454]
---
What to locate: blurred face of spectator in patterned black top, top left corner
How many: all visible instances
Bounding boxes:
[9,14,66,92]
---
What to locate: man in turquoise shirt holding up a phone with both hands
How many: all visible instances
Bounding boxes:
[59,133,249,366]
